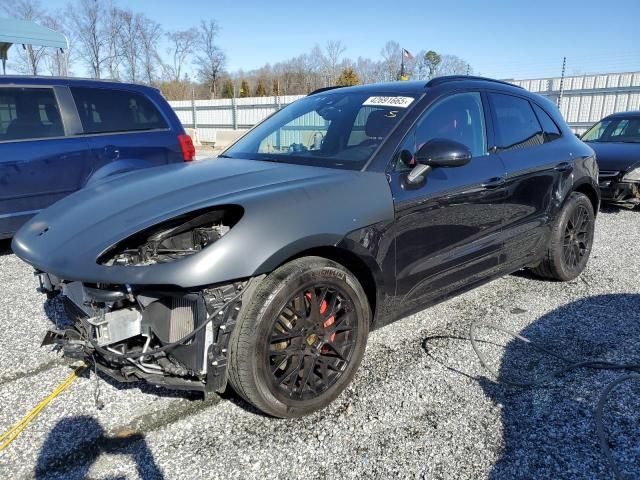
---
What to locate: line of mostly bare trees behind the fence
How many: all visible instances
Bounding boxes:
[0,0,473,100]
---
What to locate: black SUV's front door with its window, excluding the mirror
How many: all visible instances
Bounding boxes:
[389,91,506,313]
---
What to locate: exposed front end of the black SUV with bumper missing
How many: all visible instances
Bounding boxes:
[37,273,250,393]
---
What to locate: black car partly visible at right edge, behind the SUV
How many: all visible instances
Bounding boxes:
[582,111,640,208]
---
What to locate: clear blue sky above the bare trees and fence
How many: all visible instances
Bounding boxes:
[22,0,640,79]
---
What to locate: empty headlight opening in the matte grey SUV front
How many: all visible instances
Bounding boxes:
[98,205,244,266]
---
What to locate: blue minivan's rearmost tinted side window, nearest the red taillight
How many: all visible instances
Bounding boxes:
[71,88,167,133]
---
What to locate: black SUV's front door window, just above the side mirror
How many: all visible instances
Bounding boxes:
[395,92,487,170]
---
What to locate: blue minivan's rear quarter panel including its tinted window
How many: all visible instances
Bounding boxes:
[71,87,182,178]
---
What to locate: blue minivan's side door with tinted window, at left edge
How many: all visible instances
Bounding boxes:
[0,85,92,237]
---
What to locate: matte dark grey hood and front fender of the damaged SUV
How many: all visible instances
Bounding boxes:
[12,158,393,287]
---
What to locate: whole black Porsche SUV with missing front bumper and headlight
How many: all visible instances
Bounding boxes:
[13,77,600,417]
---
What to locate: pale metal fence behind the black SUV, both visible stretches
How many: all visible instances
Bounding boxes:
[169,72,640,142]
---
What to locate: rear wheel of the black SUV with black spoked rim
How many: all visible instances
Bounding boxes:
[532,192,595,282]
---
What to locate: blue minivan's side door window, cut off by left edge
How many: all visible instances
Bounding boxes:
[0,88,64,141]
